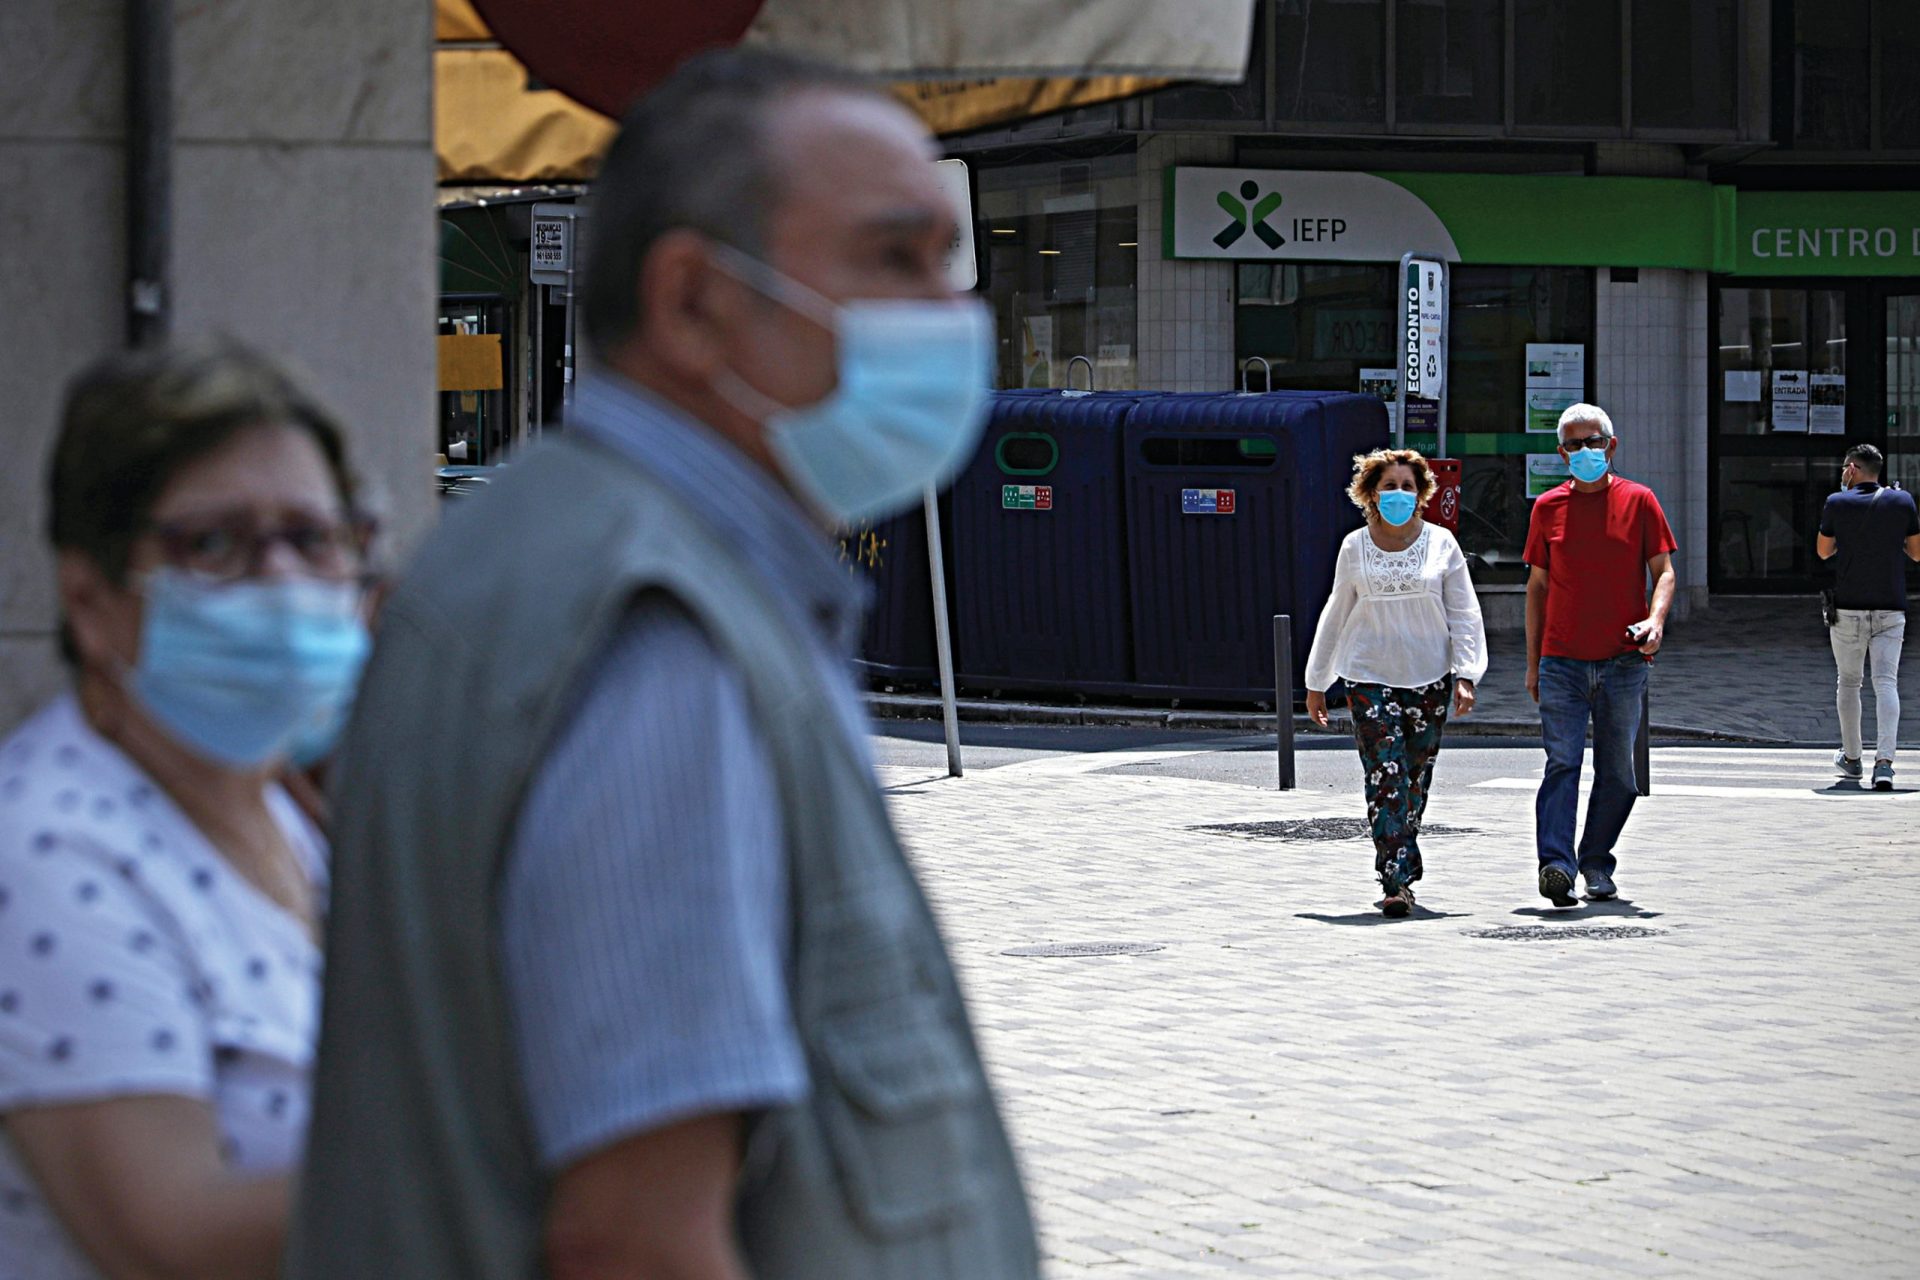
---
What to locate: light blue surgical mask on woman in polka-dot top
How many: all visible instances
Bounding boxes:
[132,568,371,770]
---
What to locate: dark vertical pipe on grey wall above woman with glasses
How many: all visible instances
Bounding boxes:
[127,0,173,345]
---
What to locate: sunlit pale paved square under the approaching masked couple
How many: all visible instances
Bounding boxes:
[885,747,1920,1280]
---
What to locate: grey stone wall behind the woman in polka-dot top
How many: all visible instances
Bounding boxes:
[0,0,438,731]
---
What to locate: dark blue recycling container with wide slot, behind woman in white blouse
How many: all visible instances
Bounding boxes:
[1123,391,1388,702]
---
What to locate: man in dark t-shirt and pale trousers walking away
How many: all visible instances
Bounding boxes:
[1818,445,1920,791]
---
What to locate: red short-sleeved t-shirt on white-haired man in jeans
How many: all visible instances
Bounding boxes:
[1526,476,1678,662]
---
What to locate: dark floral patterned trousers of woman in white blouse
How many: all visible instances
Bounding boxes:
[1346,676,1453,894]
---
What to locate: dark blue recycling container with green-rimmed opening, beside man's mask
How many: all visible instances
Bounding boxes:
[950,391,1142,693]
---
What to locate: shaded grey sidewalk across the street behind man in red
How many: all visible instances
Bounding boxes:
[1476,597,1920,750]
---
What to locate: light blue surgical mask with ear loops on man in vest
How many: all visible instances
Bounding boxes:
[716,248,993,524]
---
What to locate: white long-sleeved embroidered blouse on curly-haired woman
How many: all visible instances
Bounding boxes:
[1308,524,1486,693]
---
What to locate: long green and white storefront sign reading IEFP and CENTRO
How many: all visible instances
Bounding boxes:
[1162,167,1920,276]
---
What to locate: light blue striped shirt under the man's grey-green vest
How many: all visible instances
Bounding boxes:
[501,376,866,1171]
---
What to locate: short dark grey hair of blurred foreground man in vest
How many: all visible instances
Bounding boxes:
[580,48,879,355]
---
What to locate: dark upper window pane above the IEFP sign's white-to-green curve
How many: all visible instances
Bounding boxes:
[1394,0,1507,125]
